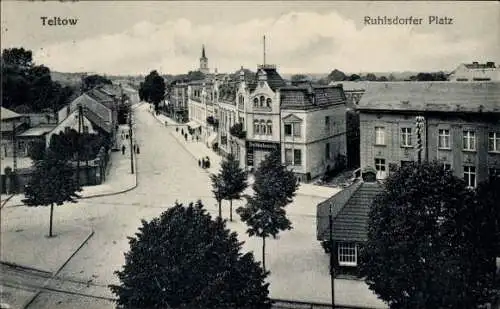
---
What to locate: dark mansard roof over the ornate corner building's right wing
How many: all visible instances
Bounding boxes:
[280,85,346,109]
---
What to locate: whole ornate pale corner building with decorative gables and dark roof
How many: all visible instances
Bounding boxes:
[214,65,346,181]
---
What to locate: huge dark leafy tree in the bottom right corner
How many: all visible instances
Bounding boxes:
[360,162,496,309]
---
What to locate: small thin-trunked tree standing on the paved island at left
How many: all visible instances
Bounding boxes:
[22,151,81,237]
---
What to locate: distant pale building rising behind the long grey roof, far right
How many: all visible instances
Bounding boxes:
[448,62,500,82]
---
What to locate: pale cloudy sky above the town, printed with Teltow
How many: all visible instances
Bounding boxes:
[1,1,500,75]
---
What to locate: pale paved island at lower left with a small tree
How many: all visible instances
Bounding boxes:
[1,224,94,272]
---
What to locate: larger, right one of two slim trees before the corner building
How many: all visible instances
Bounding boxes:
[236,151,298,269]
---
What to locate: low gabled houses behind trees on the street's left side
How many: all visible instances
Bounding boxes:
[1,85,137,189]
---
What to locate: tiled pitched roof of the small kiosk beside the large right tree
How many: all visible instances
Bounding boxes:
[317,181,382,242]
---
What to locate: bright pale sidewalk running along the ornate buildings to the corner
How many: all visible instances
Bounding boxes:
[154,114,341,199]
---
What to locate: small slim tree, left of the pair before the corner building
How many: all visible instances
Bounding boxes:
[218,154,248,221]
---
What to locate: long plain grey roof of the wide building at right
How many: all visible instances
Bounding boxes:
[358,81,500,113]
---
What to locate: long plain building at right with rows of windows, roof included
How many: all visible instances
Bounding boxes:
[357,82,500,187]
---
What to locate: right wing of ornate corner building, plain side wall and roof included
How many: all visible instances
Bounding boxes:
[279,85,346,181]
